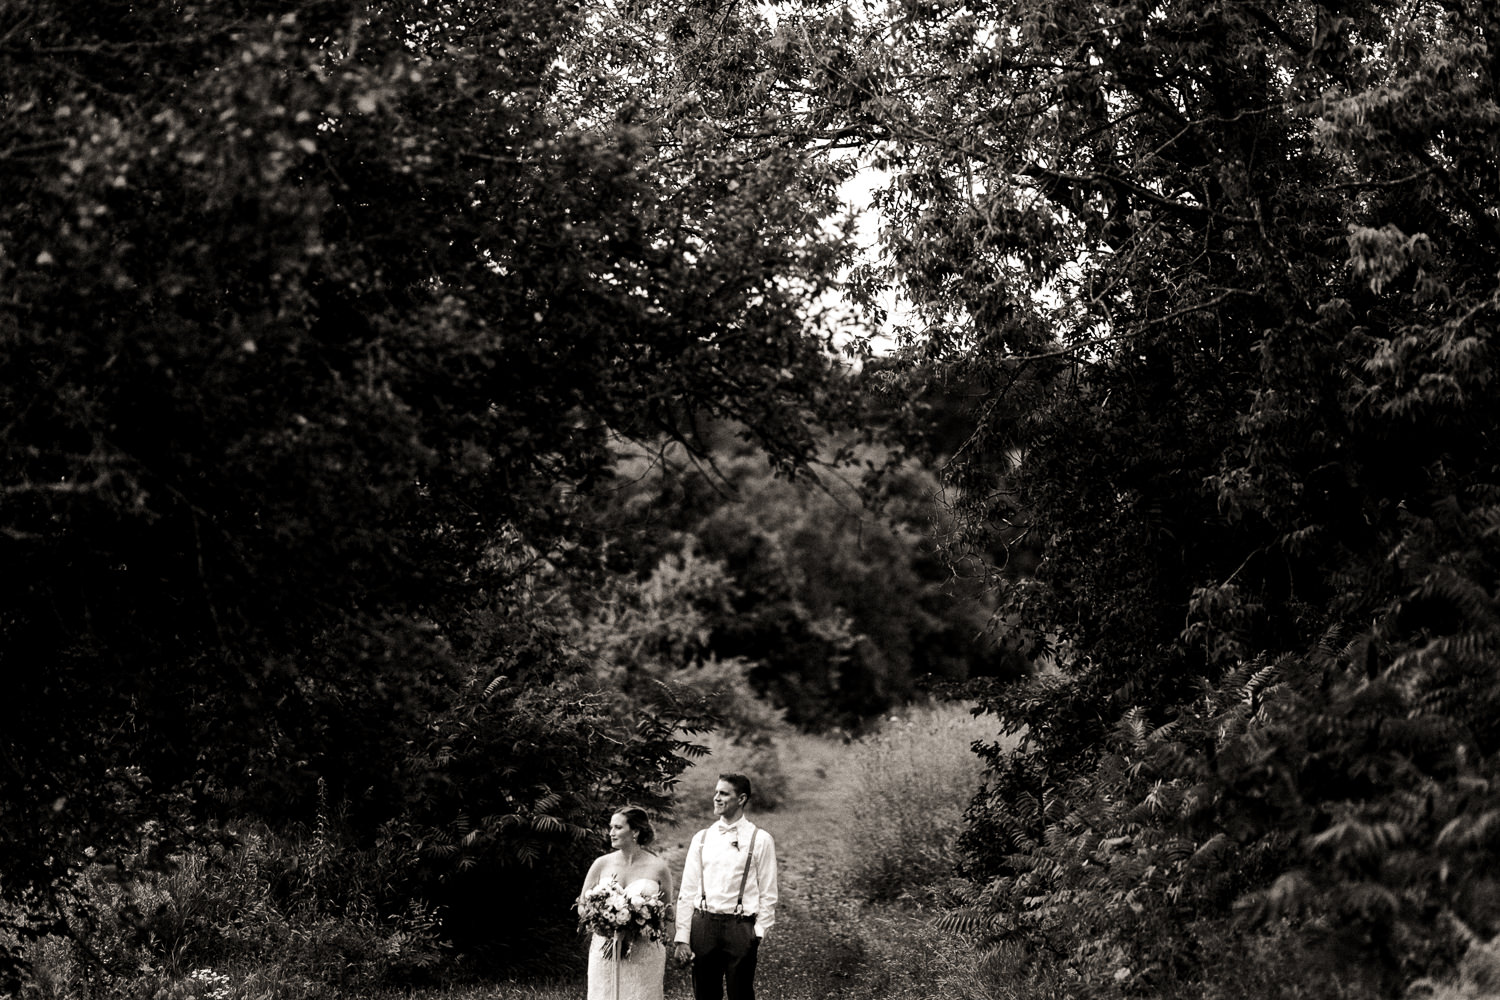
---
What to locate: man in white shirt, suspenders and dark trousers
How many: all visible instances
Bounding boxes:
[674,774,776,1000]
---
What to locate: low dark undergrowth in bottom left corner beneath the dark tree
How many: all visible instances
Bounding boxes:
[21,823,446,1000]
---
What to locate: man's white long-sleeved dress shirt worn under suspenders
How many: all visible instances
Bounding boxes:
[677,816,777,942]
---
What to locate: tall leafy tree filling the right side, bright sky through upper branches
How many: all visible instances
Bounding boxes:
[615,0,1500,993]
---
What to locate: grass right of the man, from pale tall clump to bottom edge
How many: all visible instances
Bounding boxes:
[750,703,1007,1000]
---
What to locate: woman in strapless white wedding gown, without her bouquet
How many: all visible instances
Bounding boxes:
[584,805,675,1000]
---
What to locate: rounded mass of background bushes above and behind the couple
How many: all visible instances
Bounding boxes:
[581,427,1017,730]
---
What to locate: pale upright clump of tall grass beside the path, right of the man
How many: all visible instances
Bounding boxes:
[845,703,995,901]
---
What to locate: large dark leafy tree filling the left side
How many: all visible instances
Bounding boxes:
[0,0,858,983]
